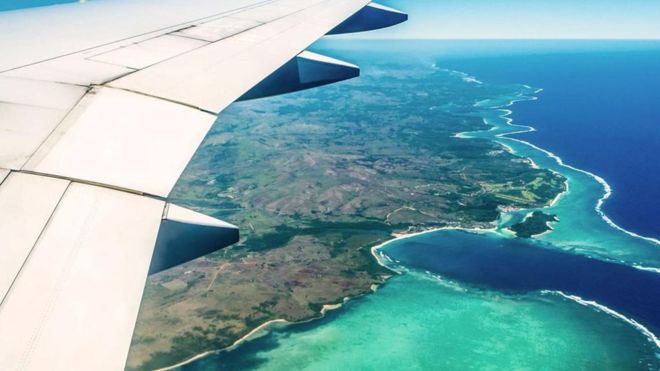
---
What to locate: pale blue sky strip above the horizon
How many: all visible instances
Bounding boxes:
[356,0,660,39]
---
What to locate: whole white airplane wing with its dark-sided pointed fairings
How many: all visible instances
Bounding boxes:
[0,0,407,370]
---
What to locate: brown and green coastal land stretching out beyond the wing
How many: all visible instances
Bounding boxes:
[127,53,566,370]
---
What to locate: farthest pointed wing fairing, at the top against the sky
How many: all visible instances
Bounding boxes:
[328,3,408,35]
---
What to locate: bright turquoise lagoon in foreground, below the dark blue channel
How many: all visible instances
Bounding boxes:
[184,272,660,370]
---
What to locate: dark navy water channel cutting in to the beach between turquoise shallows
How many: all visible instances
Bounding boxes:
[382,230,660,334]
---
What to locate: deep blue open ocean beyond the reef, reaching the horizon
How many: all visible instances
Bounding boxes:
[437,41,660,238]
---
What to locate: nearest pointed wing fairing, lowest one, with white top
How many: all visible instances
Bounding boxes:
[149,204,239,274]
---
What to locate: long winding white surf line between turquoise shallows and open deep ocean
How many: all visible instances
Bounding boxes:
[470,89,660,251]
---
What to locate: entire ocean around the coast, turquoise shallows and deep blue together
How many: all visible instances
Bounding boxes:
[182,41,660,370]
